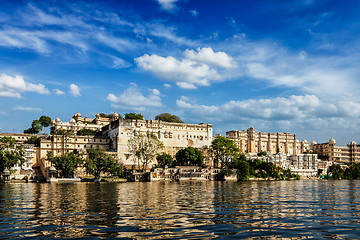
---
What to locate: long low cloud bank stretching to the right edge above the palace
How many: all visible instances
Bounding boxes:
[176,95,360,122]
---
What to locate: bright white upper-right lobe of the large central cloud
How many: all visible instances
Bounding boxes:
[184,47,235,68]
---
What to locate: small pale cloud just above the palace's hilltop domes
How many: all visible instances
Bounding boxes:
[107,84,162,111]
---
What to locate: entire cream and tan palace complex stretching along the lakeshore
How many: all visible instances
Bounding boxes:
[0,112,352,179]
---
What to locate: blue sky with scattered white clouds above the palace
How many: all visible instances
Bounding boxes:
[0,0,360,144]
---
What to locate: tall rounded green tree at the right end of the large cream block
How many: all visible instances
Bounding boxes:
[210,137,239,168]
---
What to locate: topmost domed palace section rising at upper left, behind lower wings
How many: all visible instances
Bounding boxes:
[50,112,120,134]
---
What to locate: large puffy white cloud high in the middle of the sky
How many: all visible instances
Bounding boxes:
[135,48,234,89]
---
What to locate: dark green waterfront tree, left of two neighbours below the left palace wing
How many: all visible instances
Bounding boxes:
[47,151,83,177]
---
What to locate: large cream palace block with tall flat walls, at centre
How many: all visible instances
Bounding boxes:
[102,119,212,166]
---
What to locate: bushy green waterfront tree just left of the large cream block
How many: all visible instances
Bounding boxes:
[84,147,121,179]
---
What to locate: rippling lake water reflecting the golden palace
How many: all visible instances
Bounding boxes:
[0,180,360,239]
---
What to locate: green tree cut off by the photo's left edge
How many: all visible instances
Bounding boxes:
[0,137,26,173]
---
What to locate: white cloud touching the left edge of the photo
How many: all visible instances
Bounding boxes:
[0,73,50,98]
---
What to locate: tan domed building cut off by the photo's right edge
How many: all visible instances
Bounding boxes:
[311,138,360,163]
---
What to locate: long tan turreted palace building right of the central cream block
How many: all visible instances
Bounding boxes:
[226,127,309,154]
